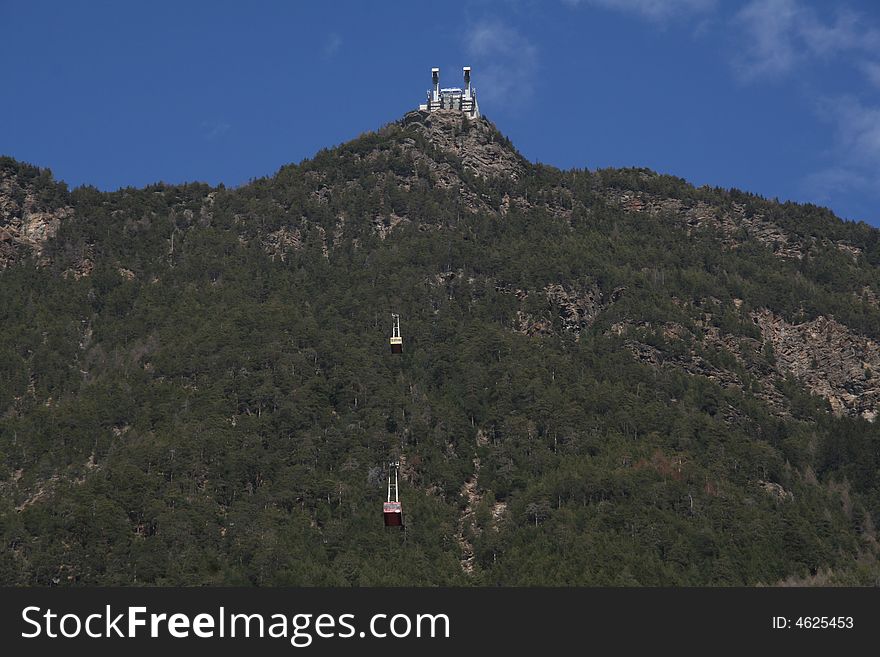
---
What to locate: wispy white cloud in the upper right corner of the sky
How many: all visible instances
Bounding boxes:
[735,0,880,81]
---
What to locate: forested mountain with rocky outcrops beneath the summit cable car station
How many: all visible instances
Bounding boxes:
[0,111,880,586]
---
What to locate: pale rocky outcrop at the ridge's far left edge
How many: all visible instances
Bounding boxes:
[0,167,73,269]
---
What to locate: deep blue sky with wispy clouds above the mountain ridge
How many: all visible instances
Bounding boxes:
[0,0,880,225]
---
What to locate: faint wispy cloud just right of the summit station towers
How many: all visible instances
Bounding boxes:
[465,21,539,109]
